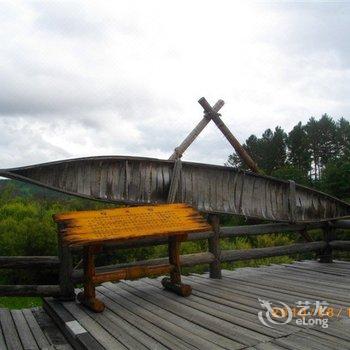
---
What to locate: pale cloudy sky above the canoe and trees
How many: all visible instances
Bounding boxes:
[0,0,350,168]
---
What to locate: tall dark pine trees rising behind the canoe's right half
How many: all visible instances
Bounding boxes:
[227,114,350,199]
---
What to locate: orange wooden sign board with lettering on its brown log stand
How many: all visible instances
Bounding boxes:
[54,204,211,312]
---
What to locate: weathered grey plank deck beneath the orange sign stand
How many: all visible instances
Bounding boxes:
[0,261,350,350]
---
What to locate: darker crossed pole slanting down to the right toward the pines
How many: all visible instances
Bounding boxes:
[198,97,259,173]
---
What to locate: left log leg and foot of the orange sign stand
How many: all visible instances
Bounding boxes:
[78,246,105,312]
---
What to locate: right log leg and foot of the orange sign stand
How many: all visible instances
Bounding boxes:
[162,236,192,297]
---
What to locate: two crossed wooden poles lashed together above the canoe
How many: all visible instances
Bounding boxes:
[169,97,259,173]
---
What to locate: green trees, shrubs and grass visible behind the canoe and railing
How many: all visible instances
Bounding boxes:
[0,115,350,307]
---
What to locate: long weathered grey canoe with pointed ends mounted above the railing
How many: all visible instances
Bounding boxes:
[0,156,350,221]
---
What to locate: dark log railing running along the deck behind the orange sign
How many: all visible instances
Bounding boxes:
[0,215,350,299]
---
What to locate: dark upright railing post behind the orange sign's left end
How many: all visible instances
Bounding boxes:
[58,224,75,300]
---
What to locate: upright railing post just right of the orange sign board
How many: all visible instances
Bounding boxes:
[208,214,222,278]
